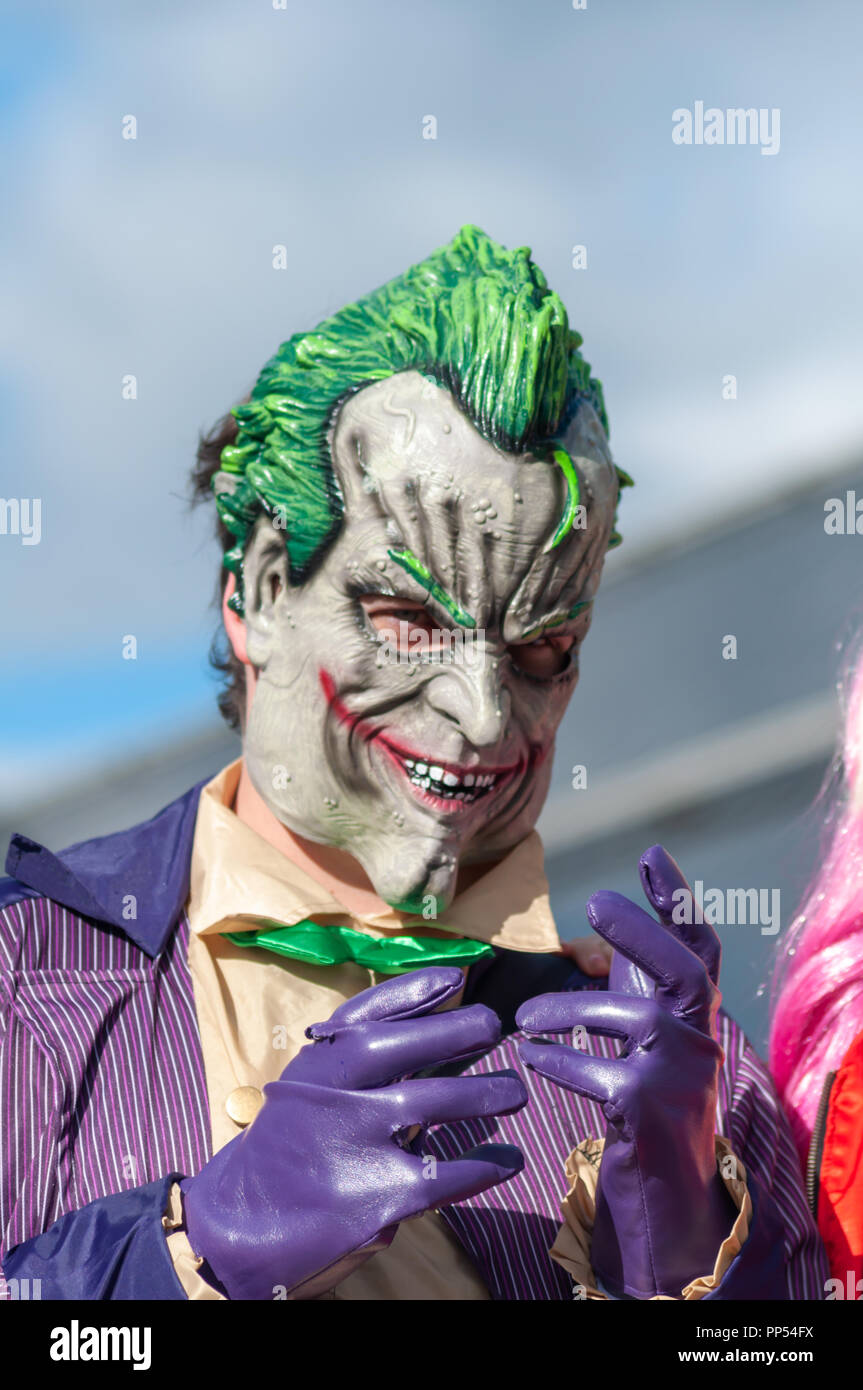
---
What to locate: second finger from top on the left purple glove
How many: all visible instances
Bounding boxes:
[290,1004,500,1090]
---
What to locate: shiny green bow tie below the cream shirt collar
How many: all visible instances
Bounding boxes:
[222,922,495,974]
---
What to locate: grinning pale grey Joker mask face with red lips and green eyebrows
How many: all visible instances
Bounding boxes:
[214,232,620,913]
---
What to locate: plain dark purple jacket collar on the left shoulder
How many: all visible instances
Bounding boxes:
[0,778,208,956]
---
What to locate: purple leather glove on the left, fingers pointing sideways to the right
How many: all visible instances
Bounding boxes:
[181,966,527,1298]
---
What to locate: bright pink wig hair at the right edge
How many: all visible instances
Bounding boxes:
[770,644,863,1163]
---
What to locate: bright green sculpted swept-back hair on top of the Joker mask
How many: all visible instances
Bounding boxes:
[217,227,622,613]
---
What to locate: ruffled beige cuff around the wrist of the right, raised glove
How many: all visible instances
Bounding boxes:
[549,1134,752,1302]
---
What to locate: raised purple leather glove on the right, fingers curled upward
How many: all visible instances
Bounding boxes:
[516,845,737,1298]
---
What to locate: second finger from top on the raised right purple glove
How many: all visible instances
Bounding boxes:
[586,891,716,1027]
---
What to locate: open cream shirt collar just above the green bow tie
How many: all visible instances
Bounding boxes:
[188,760,560,952]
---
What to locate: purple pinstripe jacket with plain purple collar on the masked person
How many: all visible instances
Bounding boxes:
[0,785,828,1300]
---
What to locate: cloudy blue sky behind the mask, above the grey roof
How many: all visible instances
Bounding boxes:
[0,0,863,798]
